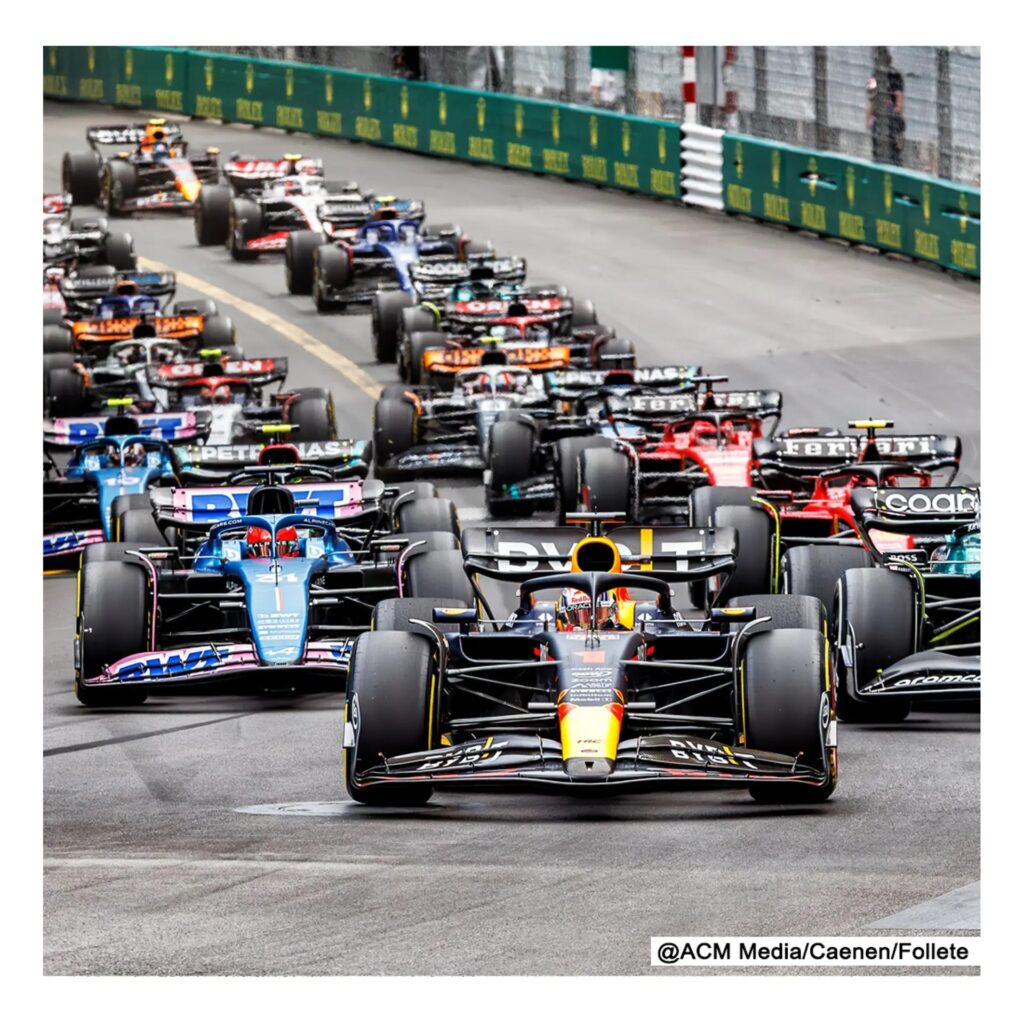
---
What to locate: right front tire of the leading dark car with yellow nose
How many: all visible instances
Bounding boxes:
[742,629,836,804]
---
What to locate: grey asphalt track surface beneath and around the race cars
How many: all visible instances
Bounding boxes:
[43,104,980,975]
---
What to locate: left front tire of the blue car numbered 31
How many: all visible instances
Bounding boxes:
[75,556,151,708]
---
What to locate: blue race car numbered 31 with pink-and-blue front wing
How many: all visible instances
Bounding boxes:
[75,486,472,706]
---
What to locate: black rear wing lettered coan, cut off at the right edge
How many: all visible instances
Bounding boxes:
[850,486,981,540]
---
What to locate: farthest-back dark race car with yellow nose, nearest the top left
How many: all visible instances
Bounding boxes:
[61,118,220,217]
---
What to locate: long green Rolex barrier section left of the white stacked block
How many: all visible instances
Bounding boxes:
[43,46,679,199]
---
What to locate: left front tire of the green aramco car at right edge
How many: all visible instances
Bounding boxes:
[836,566,919,723]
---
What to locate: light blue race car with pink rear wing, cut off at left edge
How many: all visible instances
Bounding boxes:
[43,414,210,568]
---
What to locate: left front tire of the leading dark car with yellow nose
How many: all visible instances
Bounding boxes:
[344,630,440,807]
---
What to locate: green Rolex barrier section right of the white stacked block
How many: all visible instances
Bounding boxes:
[722,133,981,278]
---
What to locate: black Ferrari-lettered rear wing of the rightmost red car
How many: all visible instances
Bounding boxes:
[754,431,963,475]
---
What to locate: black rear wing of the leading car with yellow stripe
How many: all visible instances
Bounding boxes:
[462,526,738,582]
